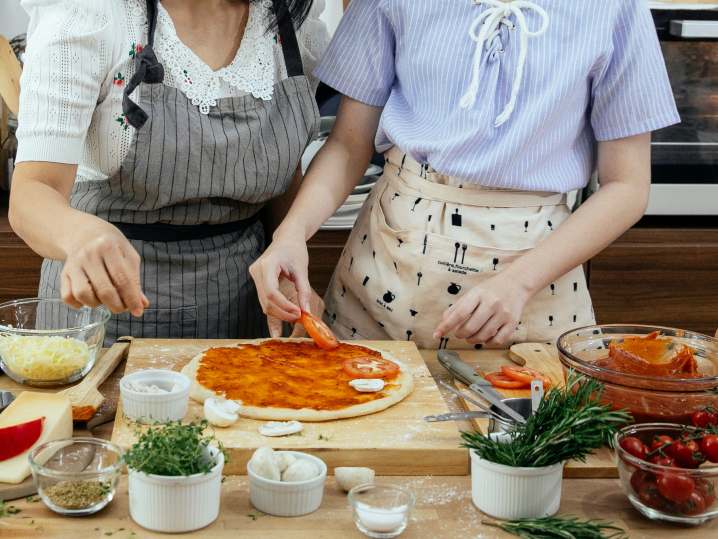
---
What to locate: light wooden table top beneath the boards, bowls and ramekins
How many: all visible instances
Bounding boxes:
[0,351,718,539]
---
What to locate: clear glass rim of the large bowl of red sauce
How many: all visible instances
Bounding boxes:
[556,324,718,393]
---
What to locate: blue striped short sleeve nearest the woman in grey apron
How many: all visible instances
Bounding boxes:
[314,0,396,107]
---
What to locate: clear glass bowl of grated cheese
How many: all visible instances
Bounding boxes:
[0,298,110,387]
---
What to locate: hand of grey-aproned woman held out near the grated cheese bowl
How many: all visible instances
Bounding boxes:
[61,221,149,316]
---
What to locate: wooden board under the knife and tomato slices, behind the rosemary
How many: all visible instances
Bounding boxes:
[454,344,618,477]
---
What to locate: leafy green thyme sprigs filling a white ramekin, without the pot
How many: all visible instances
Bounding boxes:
[125,419,229,476]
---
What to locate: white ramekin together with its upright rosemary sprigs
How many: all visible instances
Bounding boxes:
[462,372,631,519]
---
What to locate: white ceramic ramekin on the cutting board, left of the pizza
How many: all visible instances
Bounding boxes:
[120,370,190,423]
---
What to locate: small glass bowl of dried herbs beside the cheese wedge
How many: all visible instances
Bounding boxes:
[30,438,125,516]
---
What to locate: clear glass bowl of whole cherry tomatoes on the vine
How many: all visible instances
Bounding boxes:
[614,420,718,524]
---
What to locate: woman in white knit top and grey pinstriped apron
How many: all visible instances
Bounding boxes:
[10,0,328,342]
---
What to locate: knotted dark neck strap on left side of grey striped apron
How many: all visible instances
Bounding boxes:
[122,0,165,129]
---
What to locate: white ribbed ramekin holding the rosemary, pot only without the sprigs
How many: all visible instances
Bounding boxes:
[471,450,563,519]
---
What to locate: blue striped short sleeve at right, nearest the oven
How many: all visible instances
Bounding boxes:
[591,0,681,140]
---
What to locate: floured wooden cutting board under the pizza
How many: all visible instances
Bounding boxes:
[112,339,469,475]
